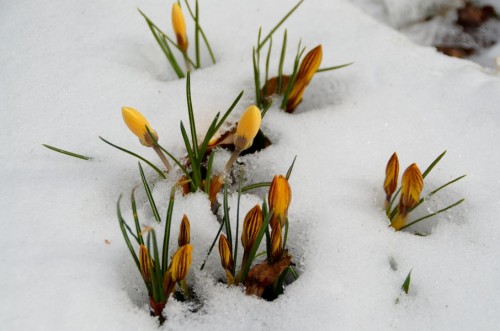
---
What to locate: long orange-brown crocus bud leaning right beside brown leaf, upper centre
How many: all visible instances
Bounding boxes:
[286,45,323,113]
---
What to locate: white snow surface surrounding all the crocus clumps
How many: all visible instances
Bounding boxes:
[0,0,500,330]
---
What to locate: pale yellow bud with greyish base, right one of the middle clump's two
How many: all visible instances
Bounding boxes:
[234,105,262,151]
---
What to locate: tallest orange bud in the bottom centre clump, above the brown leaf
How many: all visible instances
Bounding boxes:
[268,175,292,227]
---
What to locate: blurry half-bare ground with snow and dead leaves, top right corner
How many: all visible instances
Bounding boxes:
[350,0,500,70]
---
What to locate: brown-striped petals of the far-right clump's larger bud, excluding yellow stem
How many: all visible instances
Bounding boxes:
[399,163,424,214]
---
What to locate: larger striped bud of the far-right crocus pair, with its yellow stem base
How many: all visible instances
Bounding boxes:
[391,163,424,230]
